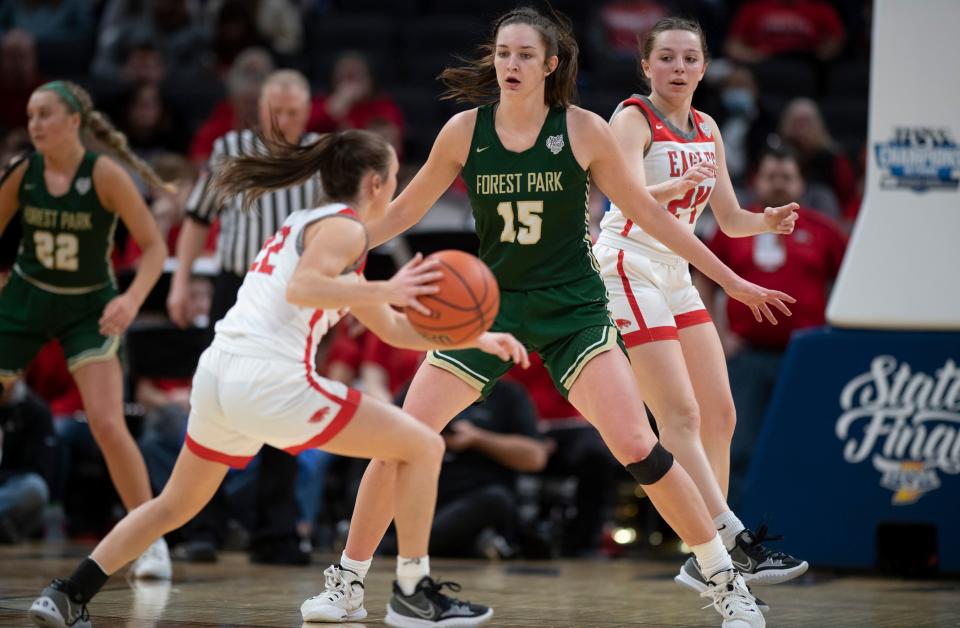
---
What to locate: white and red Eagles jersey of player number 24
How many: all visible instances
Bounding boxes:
[599,96,717,262]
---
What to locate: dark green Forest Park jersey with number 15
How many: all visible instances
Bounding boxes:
[463,105,598,290]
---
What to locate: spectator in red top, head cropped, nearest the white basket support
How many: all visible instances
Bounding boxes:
[726,0,846,63]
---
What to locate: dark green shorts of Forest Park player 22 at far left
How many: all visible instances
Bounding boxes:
[0,272,120,377]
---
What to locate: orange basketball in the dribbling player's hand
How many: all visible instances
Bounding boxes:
[406,250,500,345]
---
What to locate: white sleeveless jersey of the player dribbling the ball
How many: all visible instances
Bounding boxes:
[213,203,366,372]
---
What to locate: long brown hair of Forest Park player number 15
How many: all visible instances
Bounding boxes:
[439,5,580,107]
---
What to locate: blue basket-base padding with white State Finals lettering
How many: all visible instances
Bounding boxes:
[742,328,960,572]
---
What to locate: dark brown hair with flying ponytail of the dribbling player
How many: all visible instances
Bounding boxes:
[211,129,391,211]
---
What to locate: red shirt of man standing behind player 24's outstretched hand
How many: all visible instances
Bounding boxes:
[710,207,847,349]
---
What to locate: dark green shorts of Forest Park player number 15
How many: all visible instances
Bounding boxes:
[427,275,626,397]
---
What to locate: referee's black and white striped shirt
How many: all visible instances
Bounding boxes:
[187,129,320,276]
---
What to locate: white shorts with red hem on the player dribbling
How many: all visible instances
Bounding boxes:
[186,346,360,468]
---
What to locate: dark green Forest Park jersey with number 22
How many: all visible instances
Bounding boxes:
[14,151,117,294]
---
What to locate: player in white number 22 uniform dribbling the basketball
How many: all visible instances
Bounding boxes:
[30,131,529,626]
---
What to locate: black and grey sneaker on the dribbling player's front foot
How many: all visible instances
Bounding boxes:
[383,576,493,628]
